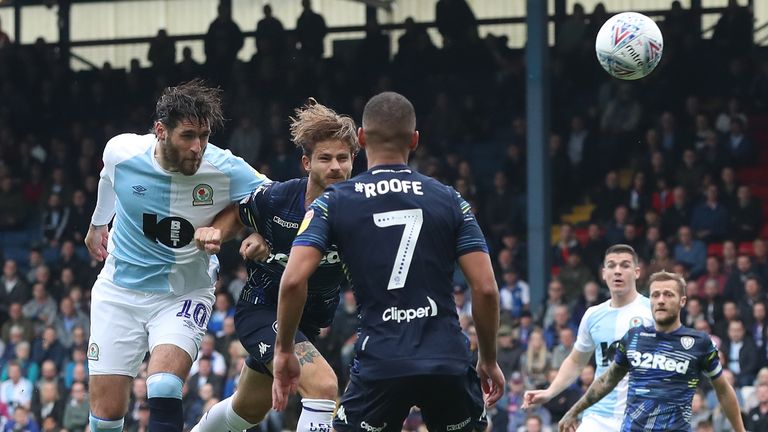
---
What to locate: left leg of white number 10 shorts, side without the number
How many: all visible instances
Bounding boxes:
[87,278,148,378]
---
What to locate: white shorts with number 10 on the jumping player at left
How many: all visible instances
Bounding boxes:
[88,278,214,378]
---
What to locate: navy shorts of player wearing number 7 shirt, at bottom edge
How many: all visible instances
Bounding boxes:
[333,367,488,432]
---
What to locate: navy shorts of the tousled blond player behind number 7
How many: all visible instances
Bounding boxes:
[235,301,317,376]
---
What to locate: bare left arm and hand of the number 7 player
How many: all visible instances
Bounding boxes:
[272,246,322,411]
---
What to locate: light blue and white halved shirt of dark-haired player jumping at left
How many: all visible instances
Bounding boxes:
[92,134,269,294]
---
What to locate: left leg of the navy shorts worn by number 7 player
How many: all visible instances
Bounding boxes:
[333,374,416,432]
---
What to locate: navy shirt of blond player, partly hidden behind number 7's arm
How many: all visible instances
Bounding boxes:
[240,178,346,330]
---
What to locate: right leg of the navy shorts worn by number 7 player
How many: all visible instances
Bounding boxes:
[418,367,488,431]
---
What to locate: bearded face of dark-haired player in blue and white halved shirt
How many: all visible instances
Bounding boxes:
[161,120,211,175]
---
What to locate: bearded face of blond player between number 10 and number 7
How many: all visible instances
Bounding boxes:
[303,140,352,188]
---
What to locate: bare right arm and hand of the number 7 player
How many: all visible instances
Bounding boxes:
[459,252,504,407]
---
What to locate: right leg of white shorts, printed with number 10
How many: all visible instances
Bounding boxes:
[147,289,214,364]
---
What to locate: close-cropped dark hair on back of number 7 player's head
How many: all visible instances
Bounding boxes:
[363,92,416,147]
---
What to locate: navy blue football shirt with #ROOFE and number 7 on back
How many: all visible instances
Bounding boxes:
[293,165,488,379]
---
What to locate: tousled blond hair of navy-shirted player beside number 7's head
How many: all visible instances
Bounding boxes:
[291,98,360,156]
